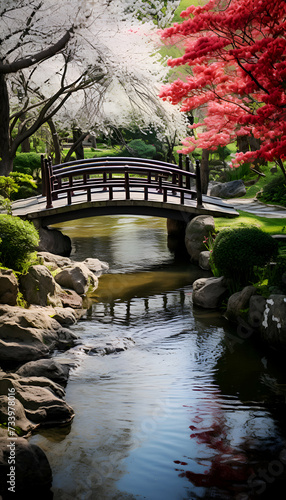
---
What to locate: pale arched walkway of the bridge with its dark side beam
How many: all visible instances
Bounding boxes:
[12,188,239,226]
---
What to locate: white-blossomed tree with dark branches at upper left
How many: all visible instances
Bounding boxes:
[0,0,185,175]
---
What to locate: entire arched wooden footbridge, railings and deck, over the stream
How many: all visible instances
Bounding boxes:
[12,157,239,226]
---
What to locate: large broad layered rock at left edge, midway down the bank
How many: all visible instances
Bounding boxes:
[0,305,76,364]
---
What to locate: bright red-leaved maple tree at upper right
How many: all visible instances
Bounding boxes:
[160,0,286,177]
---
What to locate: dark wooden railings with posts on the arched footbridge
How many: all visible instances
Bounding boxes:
[42,157,202,208]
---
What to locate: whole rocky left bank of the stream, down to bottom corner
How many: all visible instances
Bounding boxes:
[0,252,113,499]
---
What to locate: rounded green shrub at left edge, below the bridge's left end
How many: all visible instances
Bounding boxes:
[0,215,39,271]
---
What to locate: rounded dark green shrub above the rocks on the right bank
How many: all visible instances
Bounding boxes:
[212,226,278,289]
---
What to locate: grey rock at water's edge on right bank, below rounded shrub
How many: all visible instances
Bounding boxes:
[192,276,227,309]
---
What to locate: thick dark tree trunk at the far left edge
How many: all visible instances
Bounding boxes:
[0,74,13,176]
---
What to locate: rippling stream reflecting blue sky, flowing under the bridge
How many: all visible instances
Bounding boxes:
[30,216,286,500]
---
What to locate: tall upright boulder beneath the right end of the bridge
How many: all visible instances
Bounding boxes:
[185,215,215,262]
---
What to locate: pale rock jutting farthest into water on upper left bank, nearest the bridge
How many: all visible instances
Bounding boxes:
[55,262,98,295]
